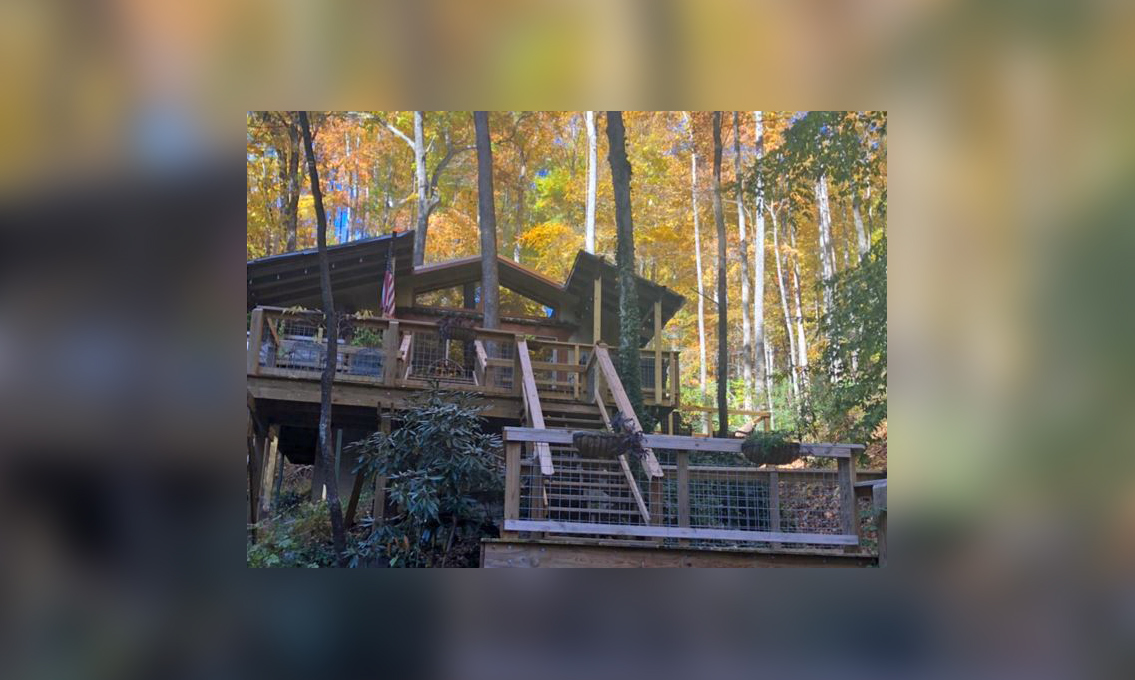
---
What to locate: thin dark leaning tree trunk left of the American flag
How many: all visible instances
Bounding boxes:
[300,111,346,566]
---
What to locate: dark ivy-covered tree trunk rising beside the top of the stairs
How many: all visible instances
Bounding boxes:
[607,111,653,431]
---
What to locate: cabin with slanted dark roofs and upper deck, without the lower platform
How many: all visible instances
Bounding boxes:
[246,232,684,494]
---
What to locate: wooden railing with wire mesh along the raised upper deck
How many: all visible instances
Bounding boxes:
[247,307,678,405]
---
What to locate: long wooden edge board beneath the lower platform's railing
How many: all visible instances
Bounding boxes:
[481,538,877,569]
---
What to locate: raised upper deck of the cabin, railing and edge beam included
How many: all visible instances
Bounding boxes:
[247,307,679,408]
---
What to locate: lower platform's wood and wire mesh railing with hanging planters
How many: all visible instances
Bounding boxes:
[504,428,861,549]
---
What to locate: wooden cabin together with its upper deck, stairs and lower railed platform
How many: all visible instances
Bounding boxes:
[247,232,874,566]
